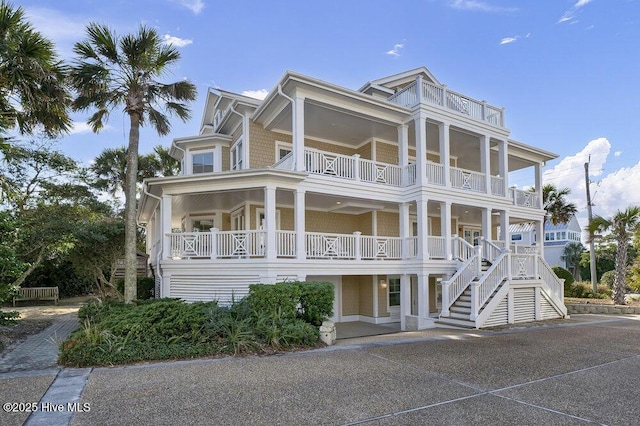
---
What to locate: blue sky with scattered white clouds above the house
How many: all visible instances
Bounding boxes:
[14,0,640,230]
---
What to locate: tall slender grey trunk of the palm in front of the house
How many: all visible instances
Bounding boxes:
[124,112,140,303]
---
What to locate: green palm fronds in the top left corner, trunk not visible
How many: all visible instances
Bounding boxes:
[0,0,71,136]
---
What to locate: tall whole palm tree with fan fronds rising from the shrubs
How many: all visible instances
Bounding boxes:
[70,23,196,303]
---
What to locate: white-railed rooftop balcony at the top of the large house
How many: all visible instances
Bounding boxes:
[388,78,505,128]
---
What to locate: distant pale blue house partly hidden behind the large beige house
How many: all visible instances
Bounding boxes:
[509,216,582,269]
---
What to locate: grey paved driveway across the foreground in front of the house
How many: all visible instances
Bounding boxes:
[0,315,640,425]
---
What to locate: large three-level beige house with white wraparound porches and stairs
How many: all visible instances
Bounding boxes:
[139,67,566,330]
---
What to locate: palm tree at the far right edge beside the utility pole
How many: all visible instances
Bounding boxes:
[589,206,640,305]
